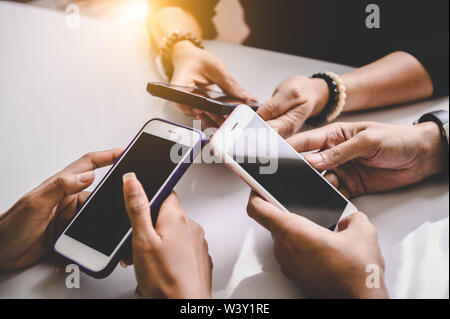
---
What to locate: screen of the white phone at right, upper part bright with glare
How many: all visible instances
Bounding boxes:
[228,116,348,228]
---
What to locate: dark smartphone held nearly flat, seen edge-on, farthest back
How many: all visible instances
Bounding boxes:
[147,82,259,115]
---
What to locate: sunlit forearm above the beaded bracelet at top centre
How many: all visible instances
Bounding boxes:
[147,7,202,47]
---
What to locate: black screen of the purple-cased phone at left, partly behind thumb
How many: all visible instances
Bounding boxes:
[65,132,189,256]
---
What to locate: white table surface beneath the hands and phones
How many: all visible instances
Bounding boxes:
[0,2,449,298]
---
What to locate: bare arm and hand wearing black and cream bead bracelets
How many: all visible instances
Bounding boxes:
[258,51,434,137]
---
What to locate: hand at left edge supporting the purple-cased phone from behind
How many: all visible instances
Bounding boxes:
[0,149,122,271]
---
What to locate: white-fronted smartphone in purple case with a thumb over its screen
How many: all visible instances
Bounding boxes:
[54,119,205,278]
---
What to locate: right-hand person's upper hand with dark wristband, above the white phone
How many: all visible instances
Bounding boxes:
[287,122,448,197]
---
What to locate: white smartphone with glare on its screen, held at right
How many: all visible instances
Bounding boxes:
[211,105,357,230]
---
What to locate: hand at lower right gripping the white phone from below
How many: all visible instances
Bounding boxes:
[247,192,388,298]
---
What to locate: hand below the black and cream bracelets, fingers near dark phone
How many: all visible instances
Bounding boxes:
[258,75,329,137]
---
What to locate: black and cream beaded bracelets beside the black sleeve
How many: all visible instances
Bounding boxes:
[308,72,347,125]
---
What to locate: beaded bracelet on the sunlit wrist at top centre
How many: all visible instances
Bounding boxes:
[158,30,204,79]
